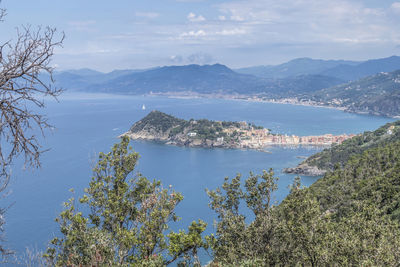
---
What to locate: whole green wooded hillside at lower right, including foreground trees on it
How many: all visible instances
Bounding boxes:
[205,137,400,266]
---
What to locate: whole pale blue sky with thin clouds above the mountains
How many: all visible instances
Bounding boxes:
[0,0,400,72]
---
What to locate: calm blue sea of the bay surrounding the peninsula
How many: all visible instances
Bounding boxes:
[2,94,392,264]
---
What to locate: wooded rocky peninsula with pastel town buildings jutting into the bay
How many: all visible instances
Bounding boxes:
[122,111,355,150]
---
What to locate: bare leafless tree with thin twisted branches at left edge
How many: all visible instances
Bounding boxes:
[0,1,64,255]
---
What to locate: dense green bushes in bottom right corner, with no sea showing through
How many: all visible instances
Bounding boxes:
[279,187,400,266]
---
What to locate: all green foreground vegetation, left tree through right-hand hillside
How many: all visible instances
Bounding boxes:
[45,127,400,266]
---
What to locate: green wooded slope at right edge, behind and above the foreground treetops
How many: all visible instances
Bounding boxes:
[310,141,400,220]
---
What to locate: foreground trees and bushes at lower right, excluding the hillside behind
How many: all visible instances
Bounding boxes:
[208,164,400,266]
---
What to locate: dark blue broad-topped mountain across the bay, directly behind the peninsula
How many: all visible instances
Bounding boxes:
[86,64,265,94]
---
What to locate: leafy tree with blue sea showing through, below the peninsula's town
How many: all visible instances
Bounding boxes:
[207,170,278,266]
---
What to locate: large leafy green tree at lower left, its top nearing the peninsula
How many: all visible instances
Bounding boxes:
[46,137,207,266]
